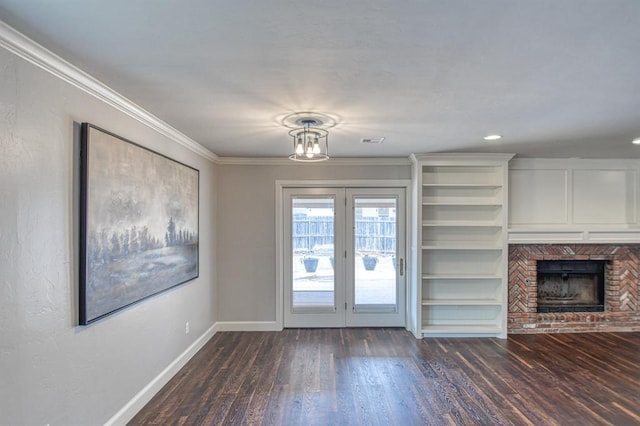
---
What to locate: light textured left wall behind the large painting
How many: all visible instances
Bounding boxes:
[0,49,217,426]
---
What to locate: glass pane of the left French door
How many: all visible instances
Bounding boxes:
[291,196,336,312]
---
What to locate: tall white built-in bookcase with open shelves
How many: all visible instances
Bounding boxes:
[412,154,513,338]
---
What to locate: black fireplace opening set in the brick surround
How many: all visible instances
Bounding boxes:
[537,260,606,312]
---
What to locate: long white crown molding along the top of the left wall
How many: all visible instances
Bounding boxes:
[0,21,218,162]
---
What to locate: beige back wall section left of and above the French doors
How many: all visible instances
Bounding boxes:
[217,162,411,323]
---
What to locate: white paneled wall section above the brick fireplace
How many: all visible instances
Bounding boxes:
[505,159,640,236]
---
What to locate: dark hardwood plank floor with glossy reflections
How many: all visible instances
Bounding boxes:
[130,328,640,426]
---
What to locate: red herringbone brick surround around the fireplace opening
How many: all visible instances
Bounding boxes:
[507,244,640,334]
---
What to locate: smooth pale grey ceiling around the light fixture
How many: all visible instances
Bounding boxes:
[0,0,640,158]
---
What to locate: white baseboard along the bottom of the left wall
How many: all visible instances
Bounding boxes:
[105,323,219,426]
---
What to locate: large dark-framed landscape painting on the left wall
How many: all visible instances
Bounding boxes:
[78,123,200,325]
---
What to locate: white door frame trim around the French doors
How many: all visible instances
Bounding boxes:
[275,179,414,330]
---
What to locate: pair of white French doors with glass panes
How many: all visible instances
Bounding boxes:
[283,188,406,327]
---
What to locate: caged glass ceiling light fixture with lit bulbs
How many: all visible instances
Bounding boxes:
[289,115,329,163]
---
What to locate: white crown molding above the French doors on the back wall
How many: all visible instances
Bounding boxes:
[216,157,411,167]
